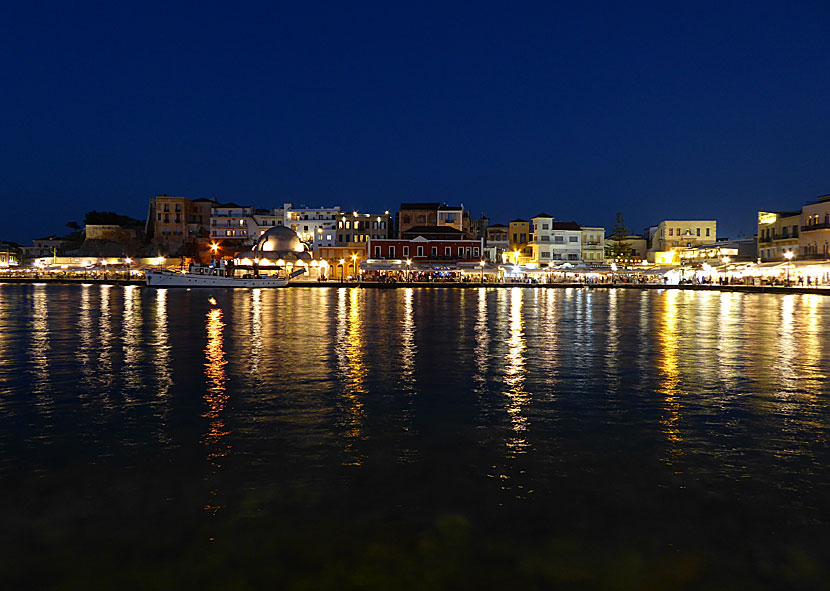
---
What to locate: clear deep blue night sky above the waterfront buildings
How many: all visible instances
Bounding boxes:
[0,1,830,244]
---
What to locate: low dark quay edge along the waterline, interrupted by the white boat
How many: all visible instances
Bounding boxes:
[0,277,830,295]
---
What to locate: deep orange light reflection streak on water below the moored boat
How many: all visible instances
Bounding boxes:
[207,308,230,514]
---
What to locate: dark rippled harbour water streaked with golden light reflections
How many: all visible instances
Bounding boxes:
[0,285,830,589]
